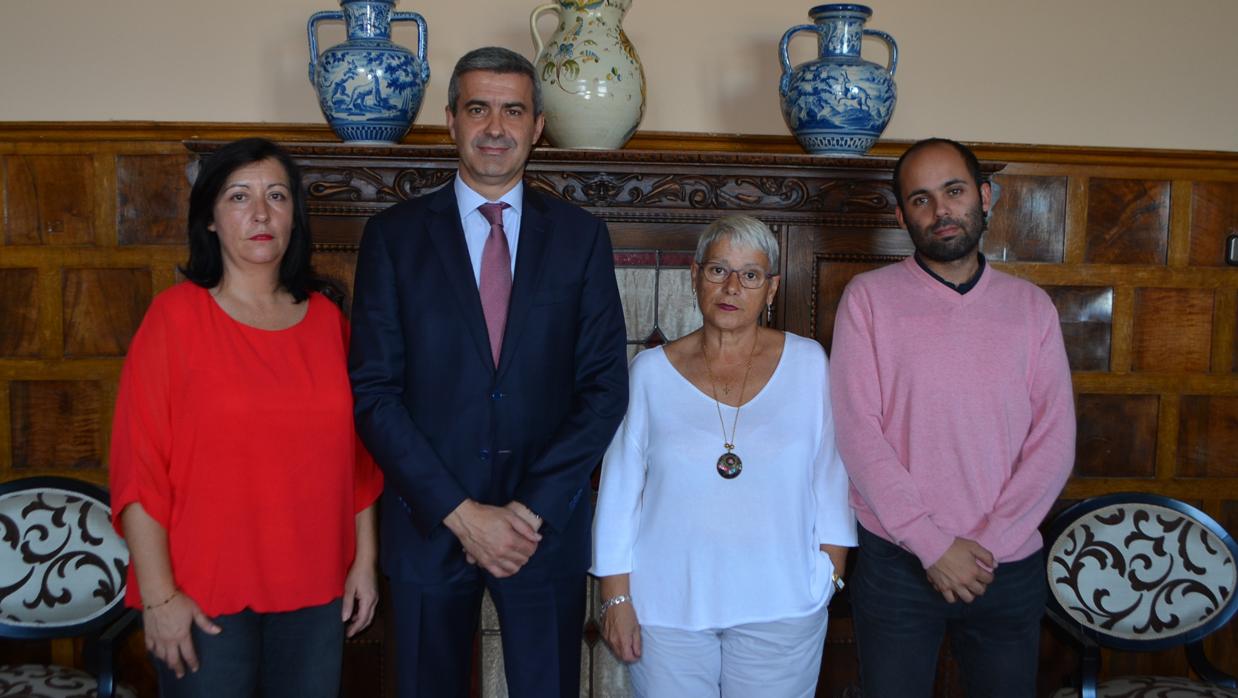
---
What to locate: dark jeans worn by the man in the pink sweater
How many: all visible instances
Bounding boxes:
[849,527,1047,698]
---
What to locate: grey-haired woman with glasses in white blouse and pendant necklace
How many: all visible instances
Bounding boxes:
[592,215,855,698]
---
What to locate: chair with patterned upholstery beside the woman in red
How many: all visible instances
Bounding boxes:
[0,478,137,698]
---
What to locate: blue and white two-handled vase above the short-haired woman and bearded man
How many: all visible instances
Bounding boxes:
[779,4,899,157]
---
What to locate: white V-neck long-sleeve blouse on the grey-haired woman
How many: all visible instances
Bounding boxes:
[591,333,855,630]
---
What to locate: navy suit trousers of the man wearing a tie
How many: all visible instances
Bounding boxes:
[390,571,586,698]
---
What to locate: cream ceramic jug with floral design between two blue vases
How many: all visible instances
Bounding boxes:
[529,0,645,150]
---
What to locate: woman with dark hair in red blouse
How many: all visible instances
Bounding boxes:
[110,139,383,698]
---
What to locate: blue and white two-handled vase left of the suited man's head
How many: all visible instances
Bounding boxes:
[306,0,430,144]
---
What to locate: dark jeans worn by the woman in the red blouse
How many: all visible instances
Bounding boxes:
[152,599,344,698]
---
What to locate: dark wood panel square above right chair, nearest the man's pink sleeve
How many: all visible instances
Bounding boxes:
[1075,394,1160,478]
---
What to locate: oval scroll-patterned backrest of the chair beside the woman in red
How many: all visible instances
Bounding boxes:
[0,478,129,637]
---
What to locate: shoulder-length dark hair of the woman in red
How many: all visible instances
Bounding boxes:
[181,139,343,304]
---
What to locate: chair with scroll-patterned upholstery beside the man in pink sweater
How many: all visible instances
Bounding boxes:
[1046,494,1238,698]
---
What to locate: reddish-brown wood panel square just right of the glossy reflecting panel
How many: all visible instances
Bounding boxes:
[1130,288,1213,373]
